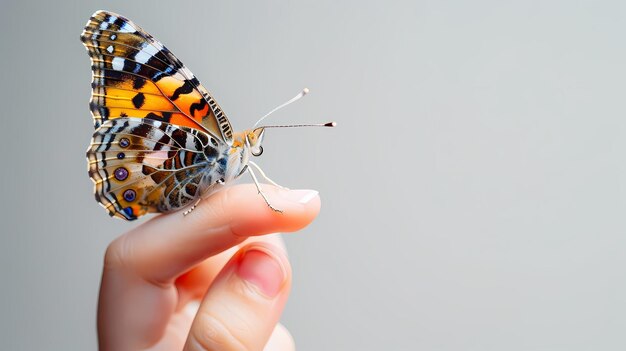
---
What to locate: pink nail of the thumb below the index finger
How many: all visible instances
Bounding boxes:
[237,248,287,297]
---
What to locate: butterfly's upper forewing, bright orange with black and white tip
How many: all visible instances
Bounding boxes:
[81,11,232,145]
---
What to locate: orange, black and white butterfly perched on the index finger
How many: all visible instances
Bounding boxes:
[80,11,335,220]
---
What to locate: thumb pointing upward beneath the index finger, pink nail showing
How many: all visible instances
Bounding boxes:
[184,242,291,351]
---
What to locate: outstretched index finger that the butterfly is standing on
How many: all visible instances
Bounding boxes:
[107,185,320,284]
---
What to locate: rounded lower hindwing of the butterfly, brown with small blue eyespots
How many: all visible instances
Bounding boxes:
[87,117,227,220]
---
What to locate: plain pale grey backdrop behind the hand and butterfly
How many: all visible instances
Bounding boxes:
[0,0,626,350]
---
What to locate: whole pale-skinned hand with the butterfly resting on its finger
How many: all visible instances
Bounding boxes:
[98,185,320,351]
